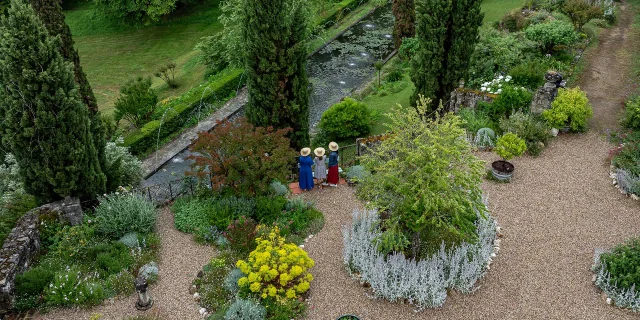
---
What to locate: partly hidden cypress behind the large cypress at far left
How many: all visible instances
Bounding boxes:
[29,0,106,188]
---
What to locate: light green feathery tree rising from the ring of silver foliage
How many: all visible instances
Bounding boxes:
[357,95,484,257]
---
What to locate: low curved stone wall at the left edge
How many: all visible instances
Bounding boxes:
[0,198,83,315]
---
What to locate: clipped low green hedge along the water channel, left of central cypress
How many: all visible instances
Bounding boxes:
[124,68,245,155]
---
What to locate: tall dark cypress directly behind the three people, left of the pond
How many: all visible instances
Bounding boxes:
[243,0,309,149]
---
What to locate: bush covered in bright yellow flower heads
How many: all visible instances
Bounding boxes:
[236,227,314,301]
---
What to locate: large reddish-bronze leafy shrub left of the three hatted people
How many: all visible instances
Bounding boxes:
[187,118,295,196]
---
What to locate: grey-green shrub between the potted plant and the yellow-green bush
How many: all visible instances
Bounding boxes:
[500,112,551,156]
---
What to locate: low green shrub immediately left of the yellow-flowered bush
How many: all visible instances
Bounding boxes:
[194,258,231,311]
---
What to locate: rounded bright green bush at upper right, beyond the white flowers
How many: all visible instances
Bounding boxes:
[524,20,578,53]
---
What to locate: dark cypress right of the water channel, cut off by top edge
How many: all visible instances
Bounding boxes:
[411,0,484,109]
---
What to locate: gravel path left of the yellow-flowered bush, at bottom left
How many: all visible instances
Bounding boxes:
[35,208,214,320]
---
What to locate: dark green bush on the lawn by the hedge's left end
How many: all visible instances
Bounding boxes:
[115,77,158,128]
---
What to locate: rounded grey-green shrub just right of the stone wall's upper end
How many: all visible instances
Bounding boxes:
[95,193,156,239]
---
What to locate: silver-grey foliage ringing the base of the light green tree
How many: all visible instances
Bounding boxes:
[342,210,496,309]
